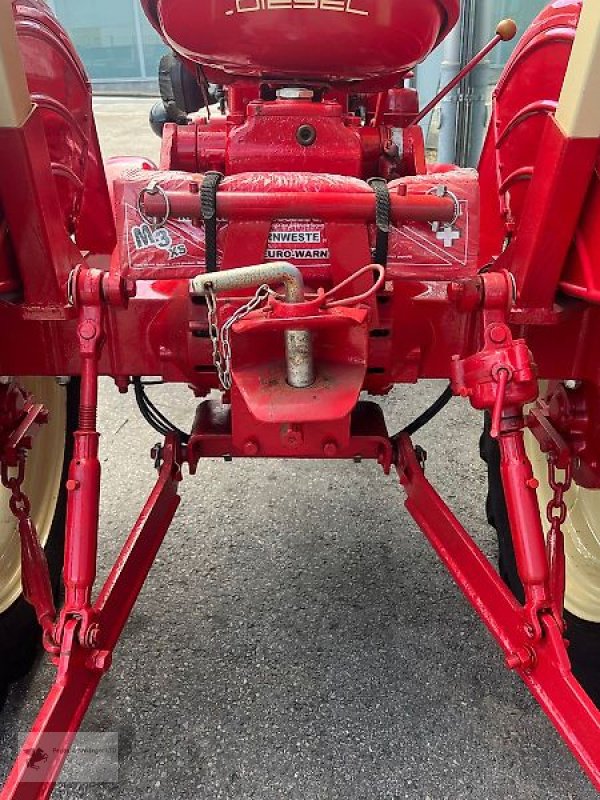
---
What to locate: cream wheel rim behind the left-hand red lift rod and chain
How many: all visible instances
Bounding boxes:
[0,378,67,613]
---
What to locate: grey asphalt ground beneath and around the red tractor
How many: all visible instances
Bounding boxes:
[0,101,596,800]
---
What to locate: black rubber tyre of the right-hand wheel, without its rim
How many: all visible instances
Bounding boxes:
[480,416,600,708]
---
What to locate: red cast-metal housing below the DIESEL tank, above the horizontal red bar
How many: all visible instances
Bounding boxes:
[160,93,426,180]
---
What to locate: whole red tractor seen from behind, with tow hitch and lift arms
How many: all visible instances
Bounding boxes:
[0,0,600,800]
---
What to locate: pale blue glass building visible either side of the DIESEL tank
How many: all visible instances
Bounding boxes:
[48,0,547,165]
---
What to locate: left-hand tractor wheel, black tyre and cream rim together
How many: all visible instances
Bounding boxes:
[0,377,79,707]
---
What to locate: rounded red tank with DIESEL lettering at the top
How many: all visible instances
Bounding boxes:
[142,0,460,83]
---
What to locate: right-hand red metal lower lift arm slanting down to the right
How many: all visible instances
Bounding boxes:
[398,437,600,790]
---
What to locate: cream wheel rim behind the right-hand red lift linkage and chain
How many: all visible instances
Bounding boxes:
[527,404,600,622]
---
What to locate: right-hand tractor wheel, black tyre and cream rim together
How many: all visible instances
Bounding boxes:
[480,417,600,708]
